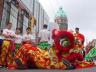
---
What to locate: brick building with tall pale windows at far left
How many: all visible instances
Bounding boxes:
[0,0,32,33]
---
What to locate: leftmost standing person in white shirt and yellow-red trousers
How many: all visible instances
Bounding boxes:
[0,22,15,67]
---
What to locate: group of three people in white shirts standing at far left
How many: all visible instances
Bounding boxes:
[0,23,35,66]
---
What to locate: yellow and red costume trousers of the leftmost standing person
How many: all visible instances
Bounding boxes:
[0,40,14,66]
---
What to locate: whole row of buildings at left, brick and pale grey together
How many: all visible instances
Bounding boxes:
[0,0,49,33]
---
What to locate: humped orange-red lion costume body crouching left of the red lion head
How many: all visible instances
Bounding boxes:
[15,44,50,68]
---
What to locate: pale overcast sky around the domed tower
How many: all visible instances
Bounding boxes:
[39,0,96,40]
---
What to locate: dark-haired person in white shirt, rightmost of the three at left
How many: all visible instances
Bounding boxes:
[23,27,35,45]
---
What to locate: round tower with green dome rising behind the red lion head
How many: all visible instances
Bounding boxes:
[55,7,68,30]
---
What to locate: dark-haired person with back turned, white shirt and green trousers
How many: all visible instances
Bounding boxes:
[39,24,50,49]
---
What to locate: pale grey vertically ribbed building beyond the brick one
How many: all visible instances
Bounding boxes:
[22,0,49,32]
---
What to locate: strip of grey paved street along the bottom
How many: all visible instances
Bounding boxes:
[0,67,96,72]
